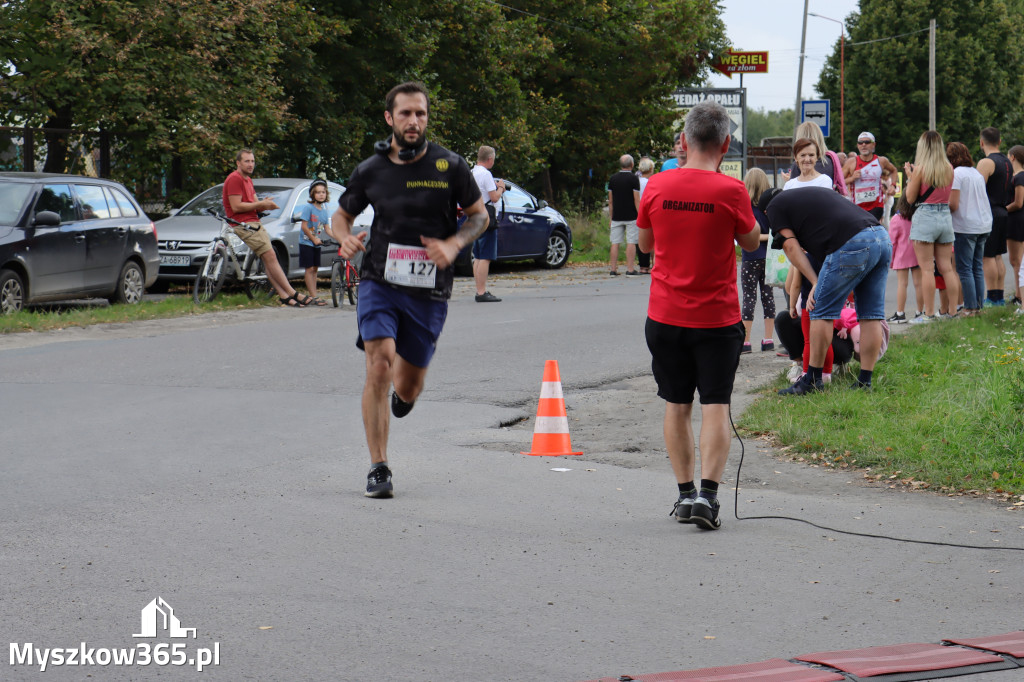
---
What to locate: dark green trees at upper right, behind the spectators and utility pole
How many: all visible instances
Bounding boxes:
[817,0,1024,163]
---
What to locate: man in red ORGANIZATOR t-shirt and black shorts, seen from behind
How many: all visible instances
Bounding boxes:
[637,100,761,530]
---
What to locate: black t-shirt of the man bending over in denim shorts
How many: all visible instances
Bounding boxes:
[767,187,879,261]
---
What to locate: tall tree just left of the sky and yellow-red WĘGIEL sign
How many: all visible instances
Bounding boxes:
[506,0,727,200]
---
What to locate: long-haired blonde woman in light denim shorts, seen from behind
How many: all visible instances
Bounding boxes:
[903,130,961,325]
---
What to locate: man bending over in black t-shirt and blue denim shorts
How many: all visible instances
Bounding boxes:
[766,187,892,395]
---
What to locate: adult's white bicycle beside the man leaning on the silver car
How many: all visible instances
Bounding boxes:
[193,208,278,304]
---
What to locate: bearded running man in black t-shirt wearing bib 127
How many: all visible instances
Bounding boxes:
[331,83,487,498]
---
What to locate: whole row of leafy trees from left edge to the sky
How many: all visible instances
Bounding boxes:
[0,0,726,203]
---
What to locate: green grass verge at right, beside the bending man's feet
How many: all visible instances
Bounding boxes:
[739,307,1024,499]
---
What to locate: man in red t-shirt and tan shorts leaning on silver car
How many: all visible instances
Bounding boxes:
[221,150,313,307]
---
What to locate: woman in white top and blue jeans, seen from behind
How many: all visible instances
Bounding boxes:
[946,142,992,315]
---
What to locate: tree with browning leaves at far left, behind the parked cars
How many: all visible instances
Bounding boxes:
[0,0,317,200]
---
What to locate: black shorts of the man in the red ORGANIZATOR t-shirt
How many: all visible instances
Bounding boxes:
[644,317,743,404]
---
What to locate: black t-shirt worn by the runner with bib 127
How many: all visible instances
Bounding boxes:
[338,142,480,300]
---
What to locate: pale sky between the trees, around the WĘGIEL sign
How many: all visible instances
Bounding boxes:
[710,0,859,112]
